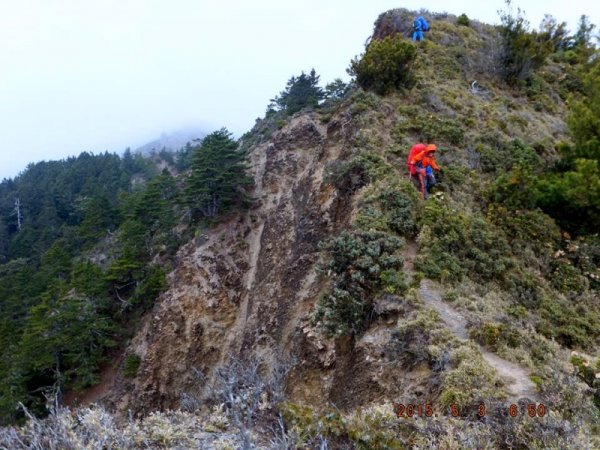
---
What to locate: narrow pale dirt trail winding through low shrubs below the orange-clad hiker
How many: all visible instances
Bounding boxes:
[404,242,538,400]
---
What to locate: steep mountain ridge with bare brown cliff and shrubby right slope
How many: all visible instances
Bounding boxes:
[0,5,600,449]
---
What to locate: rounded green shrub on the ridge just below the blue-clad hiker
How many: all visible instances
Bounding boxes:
[348,34,417,95]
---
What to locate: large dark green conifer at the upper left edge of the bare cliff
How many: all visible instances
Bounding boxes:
[185,128,253,219]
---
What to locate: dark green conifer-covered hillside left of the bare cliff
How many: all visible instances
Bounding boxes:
[0,131,251,423]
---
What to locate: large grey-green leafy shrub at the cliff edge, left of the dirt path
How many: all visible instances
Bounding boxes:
[312,231,406,336]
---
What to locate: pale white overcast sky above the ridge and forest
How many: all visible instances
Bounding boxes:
[0,0,600,178]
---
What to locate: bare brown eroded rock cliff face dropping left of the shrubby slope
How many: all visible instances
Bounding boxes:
[110,101,442,413]
